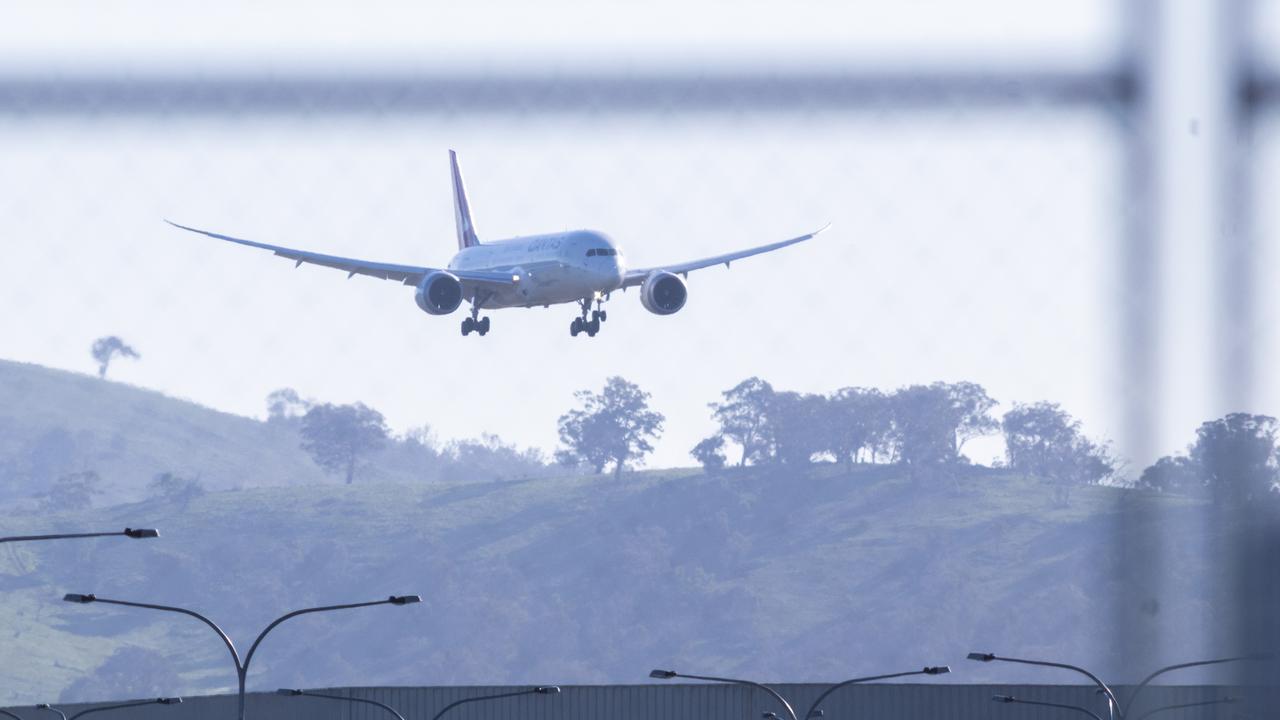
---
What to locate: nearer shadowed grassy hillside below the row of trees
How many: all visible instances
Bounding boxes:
[0,466,1206,705]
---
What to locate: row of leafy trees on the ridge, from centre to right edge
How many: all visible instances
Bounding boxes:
[556,377,1280,503]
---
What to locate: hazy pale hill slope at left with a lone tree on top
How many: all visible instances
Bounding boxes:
[0,360,410,505]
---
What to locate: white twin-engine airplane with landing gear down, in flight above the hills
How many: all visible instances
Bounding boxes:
[165,150,831,337]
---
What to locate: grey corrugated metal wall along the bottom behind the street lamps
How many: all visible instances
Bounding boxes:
[9,684,1254,720]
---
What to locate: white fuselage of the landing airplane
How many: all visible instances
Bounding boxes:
[448,231,626,309]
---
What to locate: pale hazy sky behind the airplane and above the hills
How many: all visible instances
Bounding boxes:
[0,1,1269,466]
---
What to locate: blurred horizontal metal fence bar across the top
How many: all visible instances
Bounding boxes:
[0,68,1134,115]
